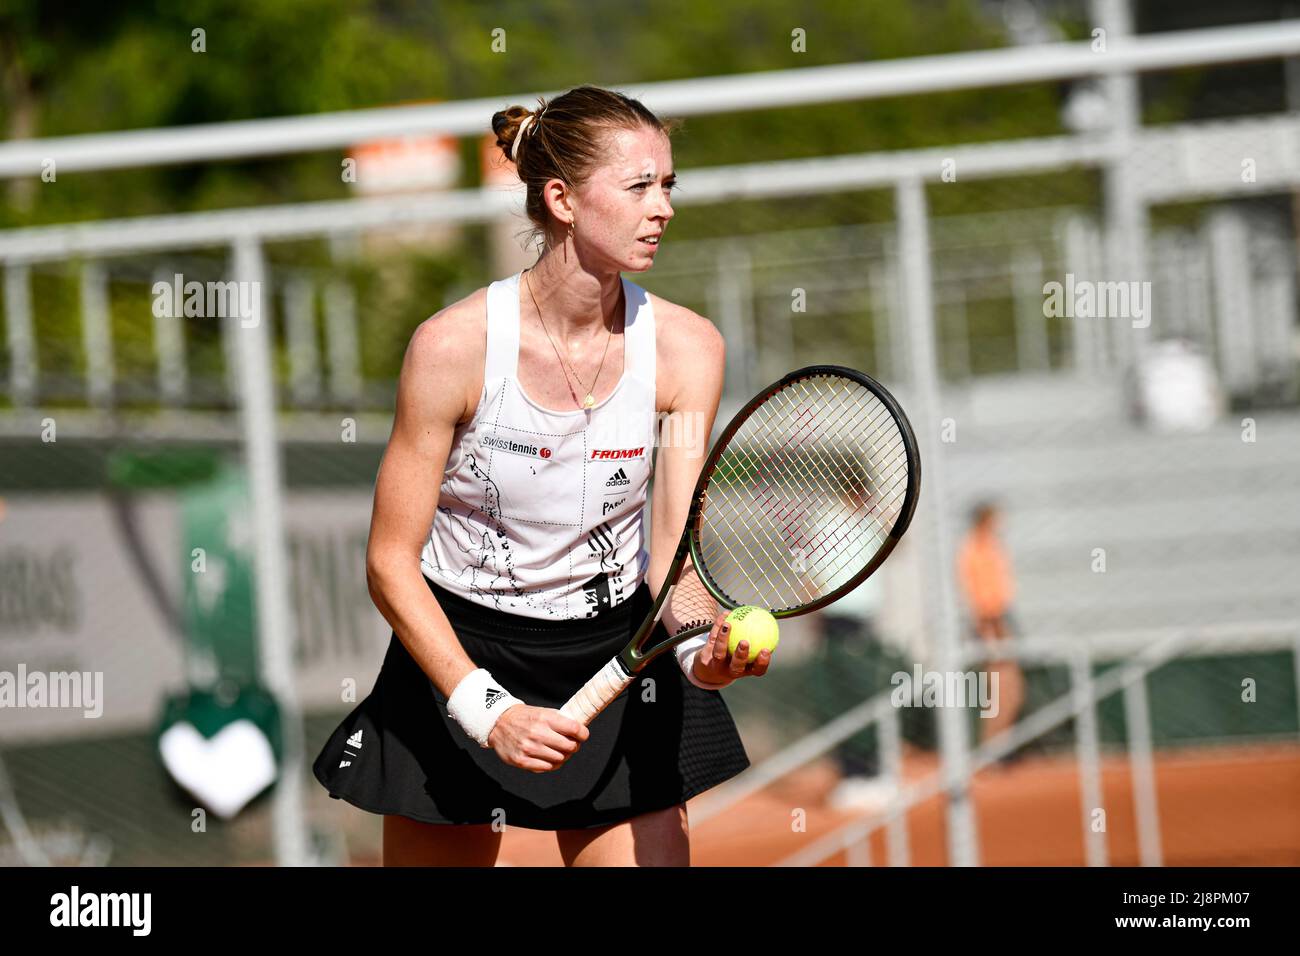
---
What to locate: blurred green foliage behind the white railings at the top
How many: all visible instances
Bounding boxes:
[0,0,1089,390]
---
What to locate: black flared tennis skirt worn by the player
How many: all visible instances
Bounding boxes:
[312,579,749,830]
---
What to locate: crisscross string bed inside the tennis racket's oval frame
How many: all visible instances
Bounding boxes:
[697,375,909,610]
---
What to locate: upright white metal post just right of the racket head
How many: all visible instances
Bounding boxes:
[894,178,979,866]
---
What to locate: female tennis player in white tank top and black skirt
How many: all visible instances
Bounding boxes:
[313,86,771,866]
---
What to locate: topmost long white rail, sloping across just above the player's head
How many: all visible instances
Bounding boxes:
[0,20,1300,177]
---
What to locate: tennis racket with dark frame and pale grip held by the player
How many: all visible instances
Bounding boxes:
[560,365,920,724]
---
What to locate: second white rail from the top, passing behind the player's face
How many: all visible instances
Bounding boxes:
[0,114,1300,263]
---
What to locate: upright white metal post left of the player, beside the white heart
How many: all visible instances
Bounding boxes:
[225,237,311,866]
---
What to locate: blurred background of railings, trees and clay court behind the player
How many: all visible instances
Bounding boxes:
[0,0,1300,865]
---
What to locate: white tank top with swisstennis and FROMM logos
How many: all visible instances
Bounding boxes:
[420,273,657,619]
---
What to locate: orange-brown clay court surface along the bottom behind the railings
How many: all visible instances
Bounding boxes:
[457,744,1300,866]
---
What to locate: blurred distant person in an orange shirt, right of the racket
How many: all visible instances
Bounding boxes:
[957,502,1024,764]
